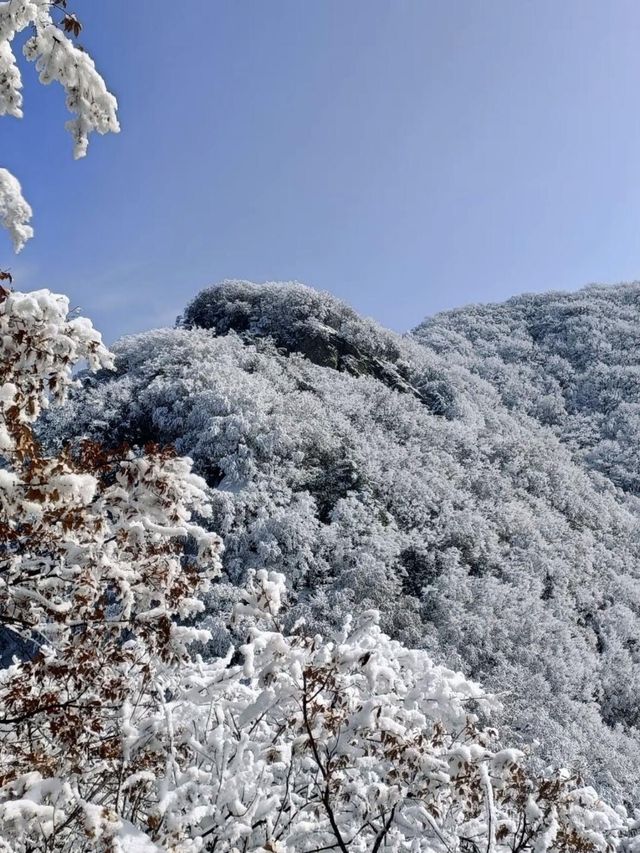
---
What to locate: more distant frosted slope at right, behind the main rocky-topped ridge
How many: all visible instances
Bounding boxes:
[414,284,640,495]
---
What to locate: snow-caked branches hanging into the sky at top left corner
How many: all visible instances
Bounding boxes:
[0,0,119,252]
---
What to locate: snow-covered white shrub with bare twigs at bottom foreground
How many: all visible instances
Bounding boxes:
[125,570,628,853]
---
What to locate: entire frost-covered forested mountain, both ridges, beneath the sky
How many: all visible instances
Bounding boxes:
[48,282,640,801]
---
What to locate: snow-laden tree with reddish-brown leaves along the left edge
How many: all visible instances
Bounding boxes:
[0,290,219,849]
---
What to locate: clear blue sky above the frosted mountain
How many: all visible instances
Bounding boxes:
[0,0,640,340]
